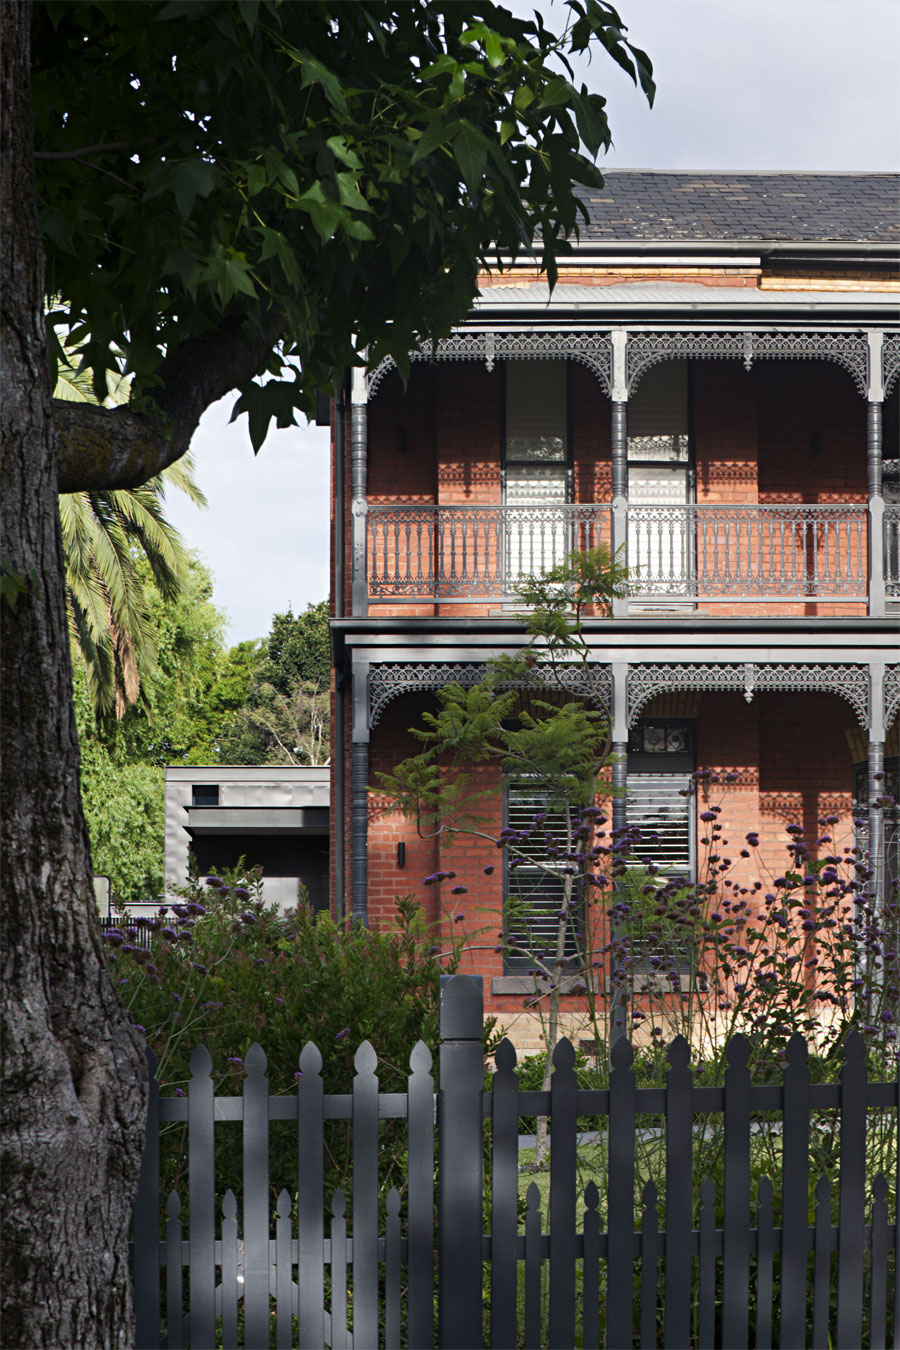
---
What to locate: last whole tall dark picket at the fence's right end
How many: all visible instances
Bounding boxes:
[835,1031,866,1350]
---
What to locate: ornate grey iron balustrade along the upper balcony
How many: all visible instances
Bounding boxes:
[367,504,874,603]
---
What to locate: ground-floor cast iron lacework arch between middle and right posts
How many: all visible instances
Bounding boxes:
[627,662,869,728]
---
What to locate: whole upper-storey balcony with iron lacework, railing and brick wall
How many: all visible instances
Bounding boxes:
[344,329,900,618]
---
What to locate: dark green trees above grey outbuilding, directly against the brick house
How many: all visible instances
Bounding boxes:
[219,601,331,765]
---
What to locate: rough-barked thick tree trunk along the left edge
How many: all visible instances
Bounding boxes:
[0,0,146,1350]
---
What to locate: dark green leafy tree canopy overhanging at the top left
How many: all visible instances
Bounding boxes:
[34,0,653,448]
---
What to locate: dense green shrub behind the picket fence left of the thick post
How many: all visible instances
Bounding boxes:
[105,869,452,1195]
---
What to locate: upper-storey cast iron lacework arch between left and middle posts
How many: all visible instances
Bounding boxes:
[368,332,613,398]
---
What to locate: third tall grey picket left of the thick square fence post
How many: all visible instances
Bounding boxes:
[297,1041,325,1350]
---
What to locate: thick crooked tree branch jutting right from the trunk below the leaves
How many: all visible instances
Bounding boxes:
[53,309,283,493]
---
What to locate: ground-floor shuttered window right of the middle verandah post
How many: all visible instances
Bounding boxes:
[626,717,695,878]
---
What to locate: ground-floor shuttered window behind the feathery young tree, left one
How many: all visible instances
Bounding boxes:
[503,782,579,971]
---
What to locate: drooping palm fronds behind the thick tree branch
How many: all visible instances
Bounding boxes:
[55,354,206,720]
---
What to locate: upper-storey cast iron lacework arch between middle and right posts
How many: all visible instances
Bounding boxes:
[625,329,869,398]
